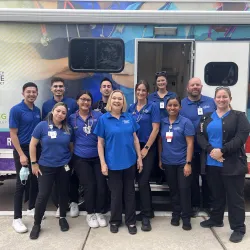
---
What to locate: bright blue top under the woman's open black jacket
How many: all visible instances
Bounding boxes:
[207,111,230,167]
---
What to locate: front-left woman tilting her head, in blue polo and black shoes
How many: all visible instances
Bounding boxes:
[30,102,73,239]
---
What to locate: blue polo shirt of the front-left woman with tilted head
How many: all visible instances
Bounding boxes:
[32,121,72,167]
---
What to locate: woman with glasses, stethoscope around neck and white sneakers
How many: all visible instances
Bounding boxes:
[69,90,107,228]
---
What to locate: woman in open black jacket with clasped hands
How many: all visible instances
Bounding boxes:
[197,87,250,243]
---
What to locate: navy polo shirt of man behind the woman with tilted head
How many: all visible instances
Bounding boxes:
[42,96,78,119]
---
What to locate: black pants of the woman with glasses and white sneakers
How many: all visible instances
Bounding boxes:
[73,155,107,214]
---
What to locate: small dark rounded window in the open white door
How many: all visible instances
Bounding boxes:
[204,62,238,86]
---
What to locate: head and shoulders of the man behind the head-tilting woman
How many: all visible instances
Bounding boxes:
[42,77,78,119]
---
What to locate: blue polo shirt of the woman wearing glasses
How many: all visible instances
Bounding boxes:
[69,110,102,158]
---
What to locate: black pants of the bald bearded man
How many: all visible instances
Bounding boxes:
[191,153,212,208]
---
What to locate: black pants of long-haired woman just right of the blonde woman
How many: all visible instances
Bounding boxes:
[137,143,156,217]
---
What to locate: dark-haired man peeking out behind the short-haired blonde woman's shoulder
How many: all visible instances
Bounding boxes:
[92,78,113,114]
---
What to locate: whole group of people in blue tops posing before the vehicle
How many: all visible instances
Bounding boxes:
[10,72,250,242]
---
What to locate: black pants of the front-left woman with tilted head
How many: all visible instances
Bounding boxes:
[35,166,70,225]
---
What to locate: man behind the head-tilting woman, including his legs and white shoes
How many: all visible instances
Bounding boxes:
[42,77,79,218]
